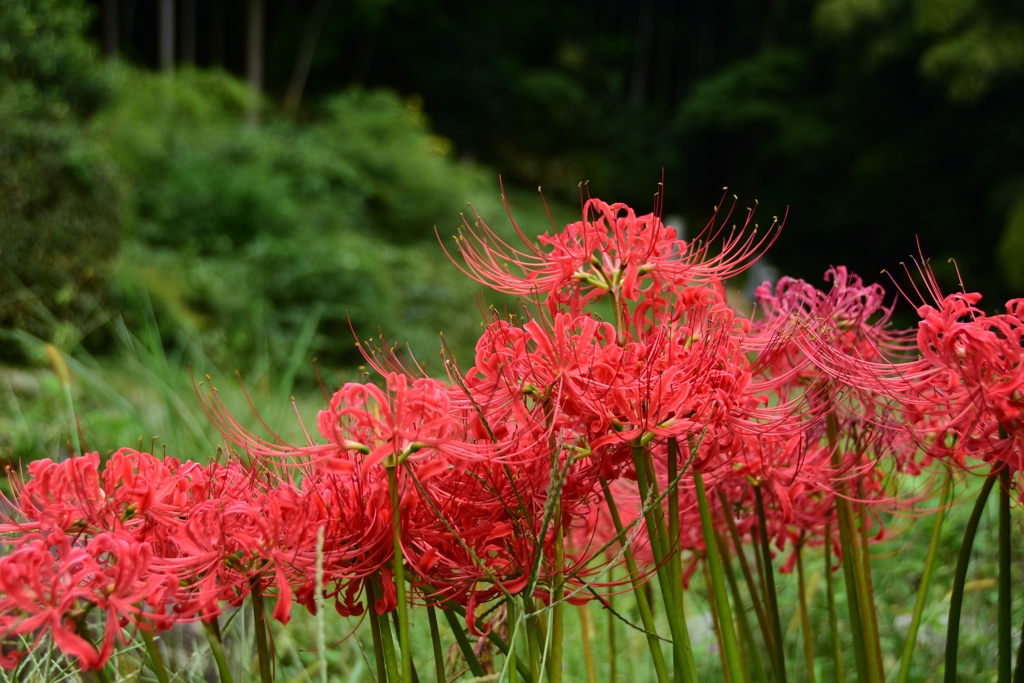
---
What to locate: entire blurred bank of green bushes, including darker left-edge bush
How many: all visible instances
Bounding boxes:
[0,0,585,382]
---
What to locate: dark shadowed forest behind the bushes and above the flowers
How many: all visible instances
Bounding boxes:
[249,0,1024,306]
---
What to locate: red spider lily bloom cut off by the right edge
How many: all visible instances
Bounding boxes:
[786,265,1024,481]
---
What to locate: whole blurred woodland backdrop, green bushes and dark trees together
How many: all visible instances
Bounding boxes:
[0,0,1024,378]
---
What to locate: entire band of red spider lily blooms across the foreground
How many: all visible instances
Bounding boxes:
[0,191,1024,669]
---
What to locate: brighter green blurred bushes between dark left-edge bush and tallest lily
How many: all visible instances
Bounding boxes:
[93,69,573,378]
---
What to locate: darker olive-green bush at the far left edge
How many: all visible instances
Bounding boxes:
[0,0,124,344]
